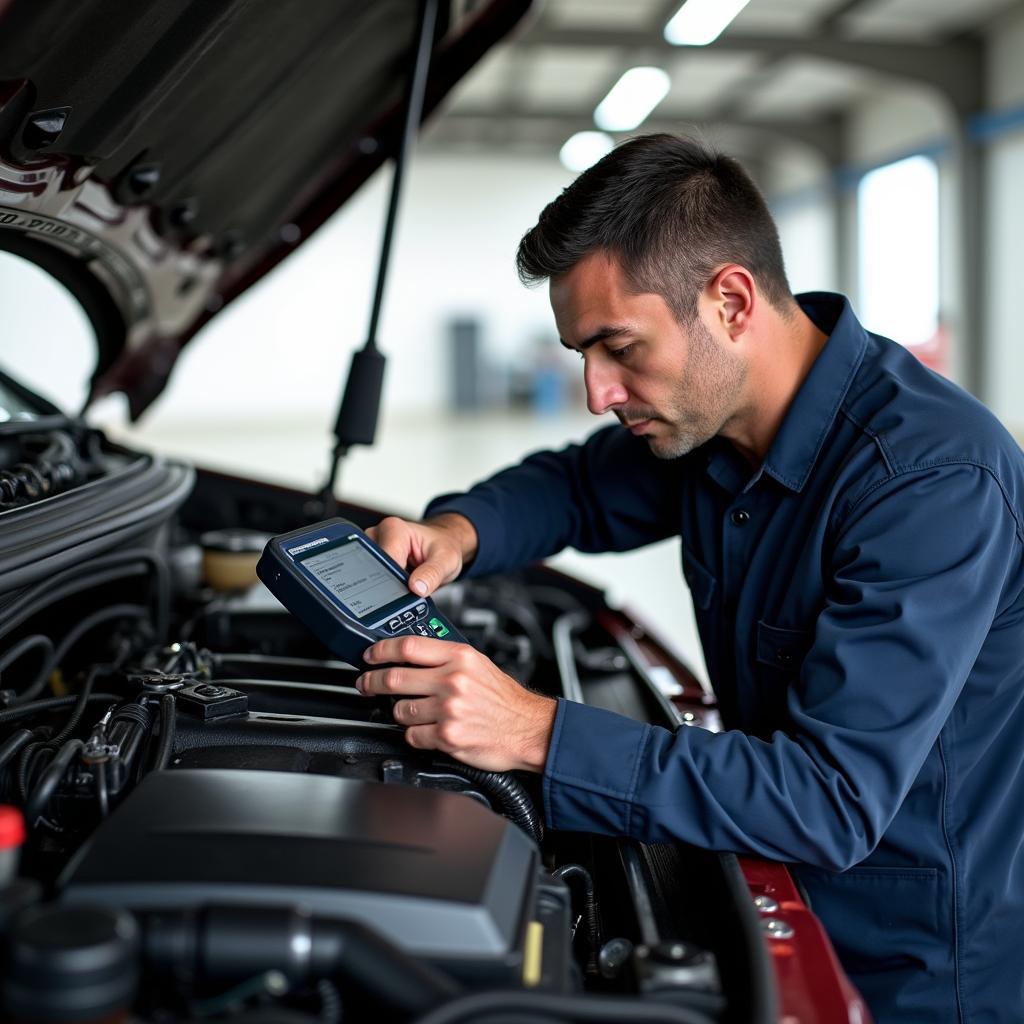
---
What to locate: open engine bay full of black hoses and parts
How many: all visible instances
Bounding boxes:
[0,405,774,1024]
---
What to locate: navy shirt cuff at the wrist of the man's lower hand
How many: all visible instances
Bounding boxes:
[544,700,651,836]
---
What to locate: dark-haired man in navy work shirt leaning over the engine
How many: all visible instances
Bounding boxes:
[359,135,1024,1024]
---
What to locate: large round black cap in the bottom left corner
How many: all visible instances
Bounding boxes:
[3,903,138,1024]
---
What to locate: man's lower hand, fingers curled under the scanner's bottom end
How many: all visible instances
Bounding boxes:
[355,636,556,772]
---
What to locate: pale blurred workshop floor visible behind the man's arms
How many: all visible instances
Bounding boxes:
[108,414,707,679]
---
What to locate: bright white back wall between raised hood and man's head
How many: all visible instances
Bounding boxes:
[114,156,568,426]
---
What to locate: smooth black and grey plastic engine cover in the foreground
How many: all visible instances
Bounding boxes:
[60,769,539,973]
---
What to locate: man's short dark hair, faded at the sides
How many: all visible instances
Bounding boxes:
[516,134,793,324]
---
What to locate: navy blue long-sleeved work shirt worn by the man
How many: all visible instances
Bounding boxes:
[427,293,1024,1024]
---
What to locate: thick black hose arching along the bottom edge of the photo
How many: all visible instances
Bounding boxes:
[416,989,713,1024]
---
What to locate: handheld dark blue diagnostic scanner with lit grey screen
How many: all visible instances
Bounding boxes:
[256,518,466,668]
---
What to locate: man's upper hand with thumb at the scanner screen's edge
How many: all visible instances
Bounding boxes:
[367,512,477,597]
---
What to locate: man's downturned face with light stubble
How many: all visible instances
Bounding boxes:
[551,252,746,459]
